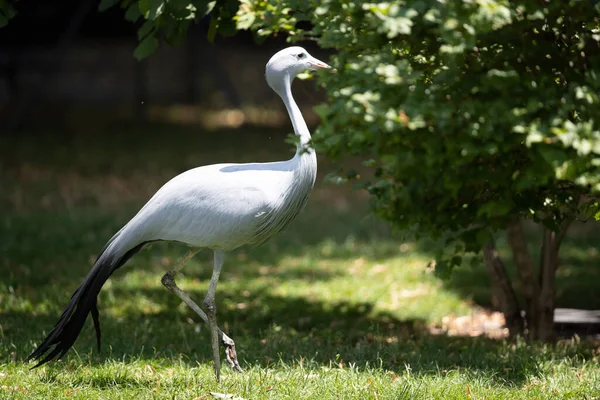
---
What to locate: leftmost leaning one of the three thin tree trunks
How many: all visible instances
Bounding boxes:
[483,240,523,337]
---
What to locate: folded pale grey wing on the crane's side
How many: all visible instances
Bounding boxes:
[115,163,291,249]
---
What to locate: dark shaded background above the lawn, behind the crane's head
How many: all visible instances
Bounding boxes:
[0,0,326,134]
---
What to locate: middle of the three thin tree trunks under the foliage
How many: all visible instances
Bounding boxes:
[506,218,540,339]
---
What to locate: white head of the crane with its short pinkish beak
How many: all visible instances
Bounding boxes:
[265,46,331,94]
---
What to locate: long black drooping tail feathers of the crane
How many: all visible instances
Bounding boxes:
[27,243,146,369]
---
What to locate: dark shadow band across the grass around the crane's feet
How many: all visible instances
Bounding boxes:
[3,291,580,387]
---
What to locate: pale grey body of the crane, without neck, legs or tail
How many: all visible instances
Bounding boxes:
[113,152,317,251]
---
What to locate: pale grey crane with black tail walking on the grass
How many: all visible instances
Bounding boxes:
[27,46,331,382]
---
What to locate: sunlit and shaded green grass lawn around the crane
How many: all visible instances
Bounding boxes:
[0,126,600,399]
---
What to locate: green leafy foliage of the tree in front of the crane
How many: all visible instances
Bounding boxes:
[237,0,600,270]
